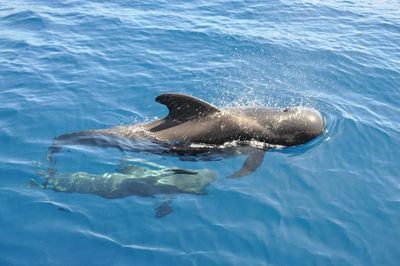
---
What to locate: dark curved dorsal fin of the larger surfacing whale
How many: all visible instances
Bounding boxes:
[156,93,219,120]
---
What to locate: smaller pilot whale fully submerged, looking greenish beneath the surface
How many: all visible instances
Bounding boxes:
[31,159,218,218]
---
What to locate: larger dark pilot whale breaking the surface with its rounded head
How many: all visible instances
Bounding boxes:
[49,93,324,177]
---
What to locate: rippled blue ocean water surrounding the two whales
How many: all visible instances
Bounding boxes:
[0,0,400,265]
